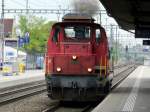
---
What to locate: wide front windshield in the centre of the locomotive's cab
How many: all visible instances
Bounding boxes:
[64,26,91,40]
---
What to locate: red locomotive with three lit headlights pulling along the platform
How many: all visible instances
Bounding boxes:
[45,14,112,101]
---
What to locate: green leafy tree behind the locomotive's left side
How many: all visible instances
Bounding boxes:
[19,16,55,53]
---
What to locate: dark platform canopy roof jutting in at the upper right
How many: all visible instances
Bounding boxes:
[100,0,150,30]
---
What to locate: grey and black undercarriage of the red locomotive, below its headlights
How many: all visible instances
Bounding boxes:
[46,75,111,101]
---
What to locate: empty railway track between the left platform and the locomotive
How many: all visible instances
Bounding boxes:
[0,81,46,105]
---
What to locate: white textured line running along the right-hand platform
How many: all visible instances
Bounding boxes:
[122,67,143,112]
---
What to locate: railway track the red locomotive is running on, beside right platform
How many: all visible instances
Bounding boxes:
[42,65,137,112]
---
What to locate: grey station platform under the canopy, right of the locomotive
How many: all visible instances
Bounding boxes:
[92,66,150,112]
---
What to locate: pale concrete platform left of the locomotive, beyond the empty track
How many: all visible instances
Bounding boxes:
[0,70,45,89]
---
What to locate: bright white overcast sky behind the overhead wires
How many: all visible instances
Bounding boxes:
[0,0,142,43]
